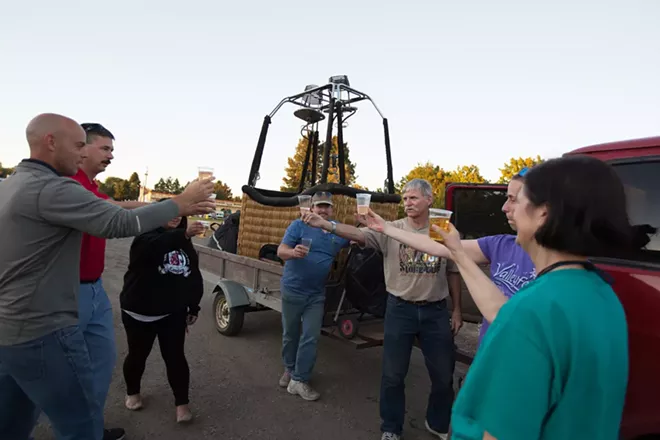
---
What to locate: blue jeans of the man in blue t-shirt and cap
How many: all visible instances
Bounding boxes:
[282,288,325,382]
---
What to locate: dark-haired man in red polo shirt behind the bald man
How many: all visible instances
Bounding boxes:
[73,123,145,440]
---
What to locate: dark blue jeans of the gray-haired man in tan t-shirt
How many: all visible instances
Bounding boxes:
[380,295,455,435]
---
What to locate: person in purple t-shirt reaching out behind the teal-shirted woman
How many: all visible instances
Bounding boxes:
[363,168,536,343]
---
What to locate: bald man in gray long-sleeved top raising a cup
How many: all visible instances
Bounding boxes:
[0,114,215,440]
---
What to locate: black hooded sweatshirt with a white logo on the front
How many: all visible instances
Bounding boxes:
[119,227,204,316]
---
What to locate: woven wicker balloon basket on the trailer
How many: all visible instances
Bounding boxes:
[238,187,399,260]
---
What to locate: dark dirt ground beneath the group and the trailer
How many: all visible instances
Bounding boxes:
[35,239,477,440]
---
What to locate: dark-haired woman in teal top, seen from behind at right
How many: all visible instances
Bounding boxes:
[442,156,634,440]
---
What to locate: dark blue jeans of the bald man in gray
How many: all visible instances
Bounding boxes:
[0,326,103,440]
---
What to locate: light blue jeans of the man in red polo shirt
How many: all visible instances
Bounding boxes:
[78,279,117,408]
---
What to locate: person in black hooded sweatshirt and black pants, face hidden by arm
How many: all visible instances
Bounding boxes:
[119,213,204,423]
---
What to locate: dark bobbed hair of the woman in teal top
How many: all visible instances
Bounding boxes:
[523,156,639,257]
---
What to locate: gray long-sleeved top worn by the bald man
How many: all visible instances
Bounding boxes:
[0,160,179,346]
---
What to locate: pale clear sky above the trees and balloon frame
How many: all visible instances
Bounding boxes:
[0,0,660,195]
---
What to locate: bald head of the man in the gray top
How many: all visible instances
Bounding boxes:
[25,113,86,176]
